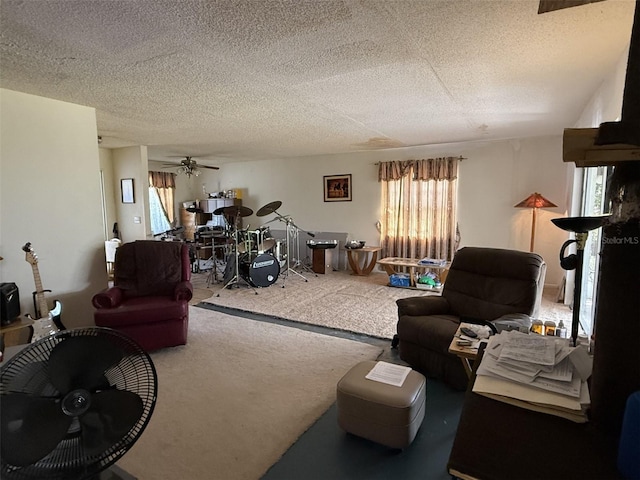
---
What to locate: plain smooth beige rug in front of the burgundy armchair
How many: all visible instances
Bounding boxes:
[118,307,382,480]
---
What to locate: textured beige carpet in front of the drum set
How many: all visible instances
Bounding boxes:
[204,271,571,339]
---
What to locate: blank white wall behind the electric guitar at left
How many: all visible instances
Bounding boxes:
[0,89,107,327]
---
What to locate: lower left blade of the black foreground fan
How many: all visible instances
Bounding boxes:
[0,393,72,467]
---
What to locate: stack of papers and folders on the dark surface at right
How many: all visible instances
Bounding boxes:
[473,330,593,423]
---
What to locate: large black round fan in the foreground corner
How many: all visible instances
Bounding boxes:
[0,328,157,480]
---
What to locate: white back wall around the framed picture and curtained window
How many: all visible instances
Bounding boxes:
[220,136,570,285]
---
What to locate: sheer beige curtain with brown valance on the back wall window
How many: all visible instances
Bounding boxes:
[378,157,459,261]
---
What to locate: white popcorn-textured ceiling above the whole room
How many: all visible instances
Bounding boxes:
[0,0,634,165]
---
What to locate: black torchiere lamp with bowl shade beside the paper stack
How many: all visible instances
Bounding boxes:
[551,215,610,347]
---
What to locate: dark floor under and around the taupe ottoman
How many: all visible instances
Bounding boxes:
[198,303,464,480]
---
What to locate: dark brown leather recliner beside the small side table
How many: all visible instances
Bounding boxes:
[396,247,546,389]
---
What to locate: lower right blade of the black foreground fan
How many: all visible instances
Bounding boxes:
[80,390,144,455]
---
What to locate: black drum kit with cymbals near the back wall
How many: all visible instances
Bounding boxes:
[213,201,313,296]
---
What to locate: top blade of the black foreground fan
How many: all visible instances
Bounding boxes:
[49,336,124,393]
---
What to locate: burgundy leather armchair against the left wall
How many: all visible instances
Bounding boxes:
[92,240,193,351]
